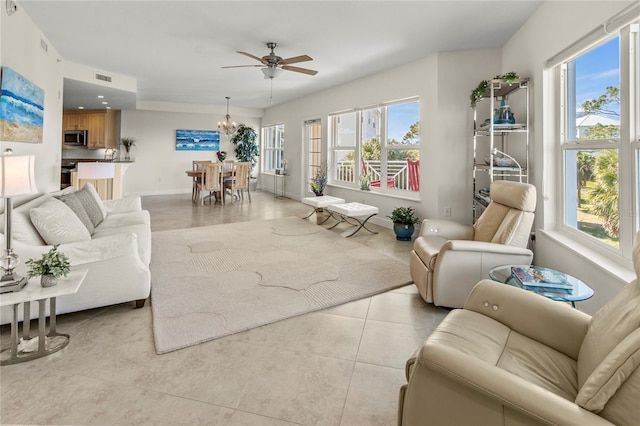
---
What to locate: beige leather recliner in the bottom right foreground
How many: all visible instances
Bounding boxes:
[398,234,640,426]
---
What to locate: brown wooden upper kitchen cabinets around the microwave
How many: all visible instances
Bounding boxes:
[62,110,118,149]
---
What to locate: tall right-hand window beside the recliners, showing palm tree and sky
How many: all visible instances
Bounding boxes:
[556,19,640,258]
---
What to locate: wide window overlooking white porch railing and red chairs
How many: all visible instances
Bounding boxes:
[329,99,420,193]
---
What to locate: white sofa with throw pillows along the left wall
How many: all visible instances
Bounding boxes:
[0,185,151,324]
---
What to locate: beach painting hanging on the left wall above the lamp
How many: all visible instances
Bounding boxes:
[0,67,44,143]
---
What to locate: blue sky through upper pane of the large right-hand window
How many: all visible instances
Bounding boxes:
[576,37,620,114]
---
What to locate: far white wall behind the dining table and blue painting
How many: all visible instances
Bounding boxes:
[120,106,262,195]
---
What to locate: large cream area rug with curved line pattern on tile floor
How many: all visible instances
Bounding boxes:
[151,217,411,354]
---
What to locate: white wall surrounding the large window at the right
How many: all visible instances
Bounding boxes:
[502,1,632,313]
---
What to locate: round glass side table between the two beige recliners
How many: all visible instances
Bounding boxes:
[489,265,593,308]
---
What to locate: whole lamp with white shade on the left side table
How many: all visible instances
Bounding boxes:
[0,149,37,293]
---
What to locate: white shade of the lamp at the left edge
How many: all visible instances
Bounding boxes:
[0,155,38,198]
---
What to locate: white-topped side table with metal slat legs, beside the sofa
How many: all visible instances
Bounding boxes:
[0,270,87,365]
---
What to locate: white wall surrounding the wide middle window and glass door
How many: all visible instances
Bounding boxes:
[262,49,500,226]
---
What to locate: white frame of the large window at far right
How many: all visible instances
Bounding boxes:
[546,22,640,262]
